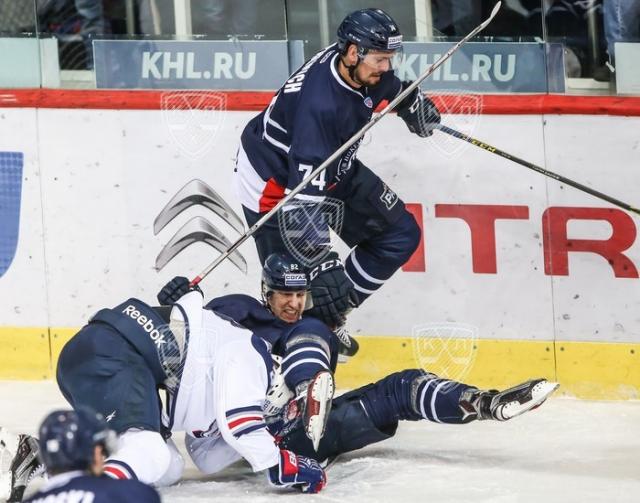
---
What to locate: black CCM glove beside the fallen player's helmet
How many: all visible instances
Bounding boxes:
[304,252,358,329]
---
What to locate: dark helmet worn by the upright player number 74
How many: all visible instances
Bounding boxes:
[338,9,402,54]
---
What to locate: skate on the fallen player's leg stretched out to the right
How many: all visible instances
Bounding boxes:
[459,379,559,422]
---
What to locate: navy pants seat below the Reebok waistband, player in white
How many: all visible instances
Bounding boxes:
[56,323,161,433]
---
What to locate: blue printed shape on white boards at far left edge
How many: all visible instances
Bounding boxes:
[0,152,24,277]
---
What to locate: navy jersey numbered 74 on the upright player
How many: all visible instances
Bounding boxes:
[236,44,402,212]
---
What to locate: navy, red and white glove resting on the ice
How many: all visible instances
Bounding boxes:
[267,449,327,493]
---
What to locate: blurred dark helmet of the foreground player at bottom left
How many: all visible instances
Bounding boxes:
[39,407,116,472]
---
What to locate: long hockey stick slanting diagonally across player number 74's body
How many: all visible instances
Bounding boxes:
[191,2,502,286]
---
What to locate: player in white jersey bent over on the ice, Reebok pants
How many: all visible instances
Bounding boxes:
[50,290,326,493]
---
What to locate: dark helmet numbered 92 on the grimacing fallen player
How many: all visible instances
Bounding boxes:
[262,253,311,309]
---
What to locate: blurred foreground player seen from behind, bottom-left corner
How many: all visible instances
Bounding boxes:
[19,407,160,503]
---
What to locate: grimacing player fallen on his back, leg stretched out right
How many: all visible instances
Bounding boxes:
[158,254,557,462]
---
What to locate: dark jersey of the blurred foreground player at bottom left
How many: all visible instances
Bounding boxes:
[24,472,160,503]
